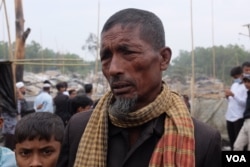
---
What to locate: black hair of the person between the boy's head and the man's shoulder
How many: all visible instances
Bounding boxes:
[71,95,94,114]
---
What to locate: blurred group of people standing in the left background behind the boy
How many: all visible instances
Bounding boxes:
[2,80,94,150]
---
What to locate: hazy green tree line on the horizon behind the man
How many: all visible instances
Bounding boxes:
[0,40,250,85]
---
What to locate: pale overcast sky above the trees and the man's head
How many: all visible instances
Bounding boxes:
[0,0,250,60]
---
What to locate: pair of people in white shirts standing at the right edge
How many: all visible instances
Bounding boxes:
[225,61,250,151]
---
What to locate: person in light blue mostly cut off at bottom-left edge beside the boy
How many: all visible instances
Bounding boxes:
[0,112,17,167]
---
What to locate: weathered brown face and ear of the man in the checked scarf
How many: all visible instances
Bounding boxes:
[100,24,171,109]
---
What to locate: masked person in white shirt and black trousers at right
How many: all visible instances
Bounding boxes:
[225,66,247,150]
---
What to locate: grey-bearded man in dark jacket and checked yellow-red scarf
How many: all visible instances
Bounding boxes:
[58,8,221,167]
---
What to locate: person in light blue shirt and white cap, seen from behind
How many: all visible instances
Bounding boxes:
[34,83,54,113]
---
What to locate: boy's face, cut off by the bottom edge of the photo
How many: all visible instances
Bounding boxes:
[15,137,61,167]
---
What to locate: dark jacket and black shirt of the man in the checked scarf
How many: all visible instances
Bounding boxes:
[57,111,221,167]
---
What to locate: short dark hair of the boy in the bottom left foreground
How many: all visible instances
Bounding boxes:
[14,112,64,144]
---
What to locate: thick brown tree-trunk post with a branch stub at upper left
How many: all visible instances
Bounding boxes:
[14,0,30,82]
